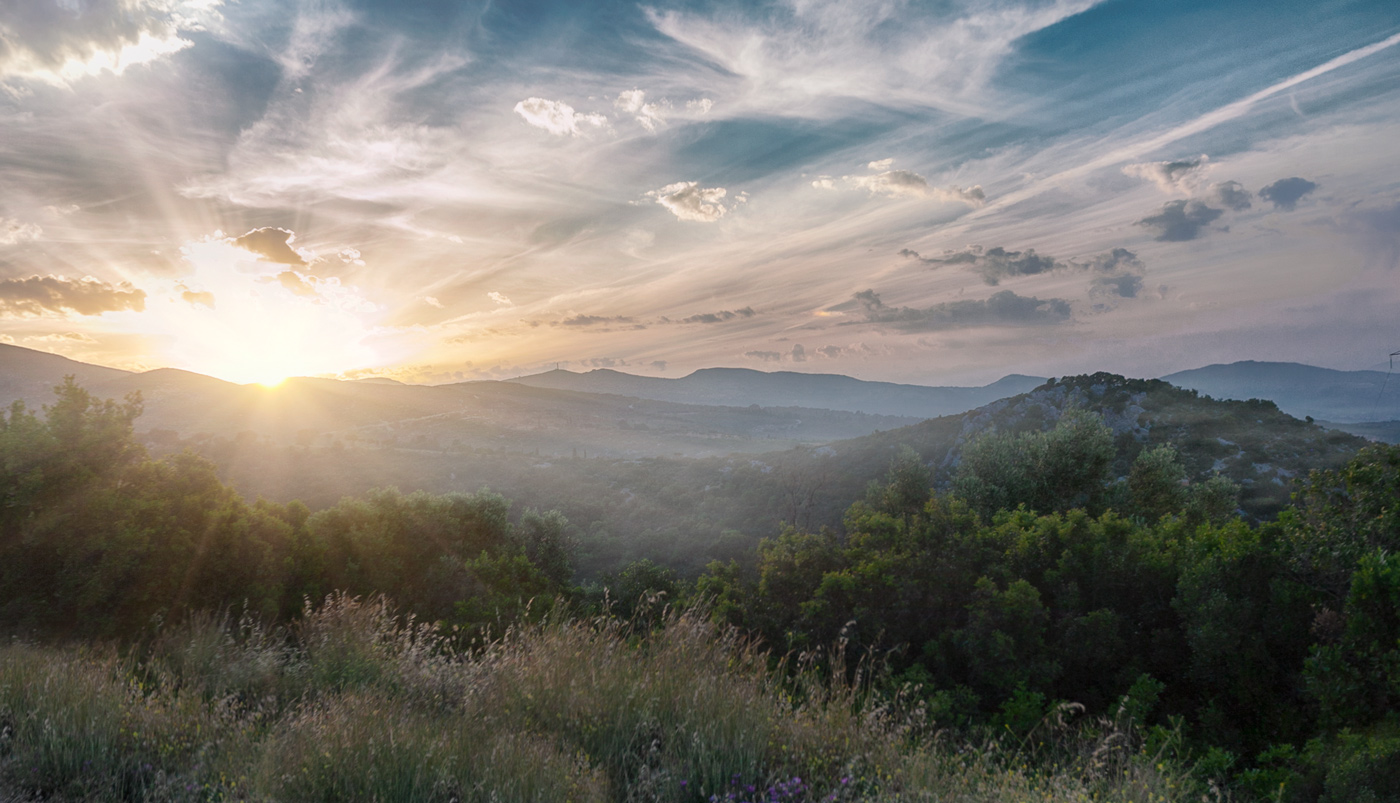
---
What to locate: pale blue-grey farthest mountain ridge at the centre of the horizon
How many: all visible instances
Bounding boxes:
[510,368,1046,418]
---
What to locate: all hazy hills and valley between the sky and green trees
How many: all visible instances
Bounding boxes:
[0,347,1377,548]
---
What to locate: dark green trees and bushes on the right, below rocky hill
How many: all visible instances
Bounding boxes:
[699,417,1400,800]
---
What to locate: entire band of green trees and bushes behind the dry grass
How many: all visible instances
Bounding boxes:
[0,382,1400,803]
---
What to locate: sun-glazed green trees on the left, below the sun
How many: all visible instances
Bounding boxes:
[0,382,573,637]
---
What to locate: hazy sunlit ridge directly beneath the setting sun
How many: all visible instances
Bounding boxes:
[0,346,920,457]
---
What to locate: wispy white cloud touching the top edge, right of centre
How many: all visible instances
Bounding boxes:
[647,0,1098,116]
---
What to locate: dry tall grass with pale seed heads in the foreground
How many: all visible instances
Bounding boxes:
[0,596,1200,803]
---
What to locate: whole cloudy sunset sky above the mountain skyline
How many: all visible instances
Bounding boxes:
[0,0,1400,385]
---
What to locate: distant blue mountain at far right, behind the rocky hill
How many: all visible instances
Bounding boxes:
[1162,360,1400,424]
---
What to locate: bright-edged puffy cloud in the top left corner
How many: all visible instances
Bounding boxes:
[0,0,210,85]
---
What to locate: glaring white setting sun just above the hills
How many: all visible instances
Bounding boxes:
[151,236,382,388]
